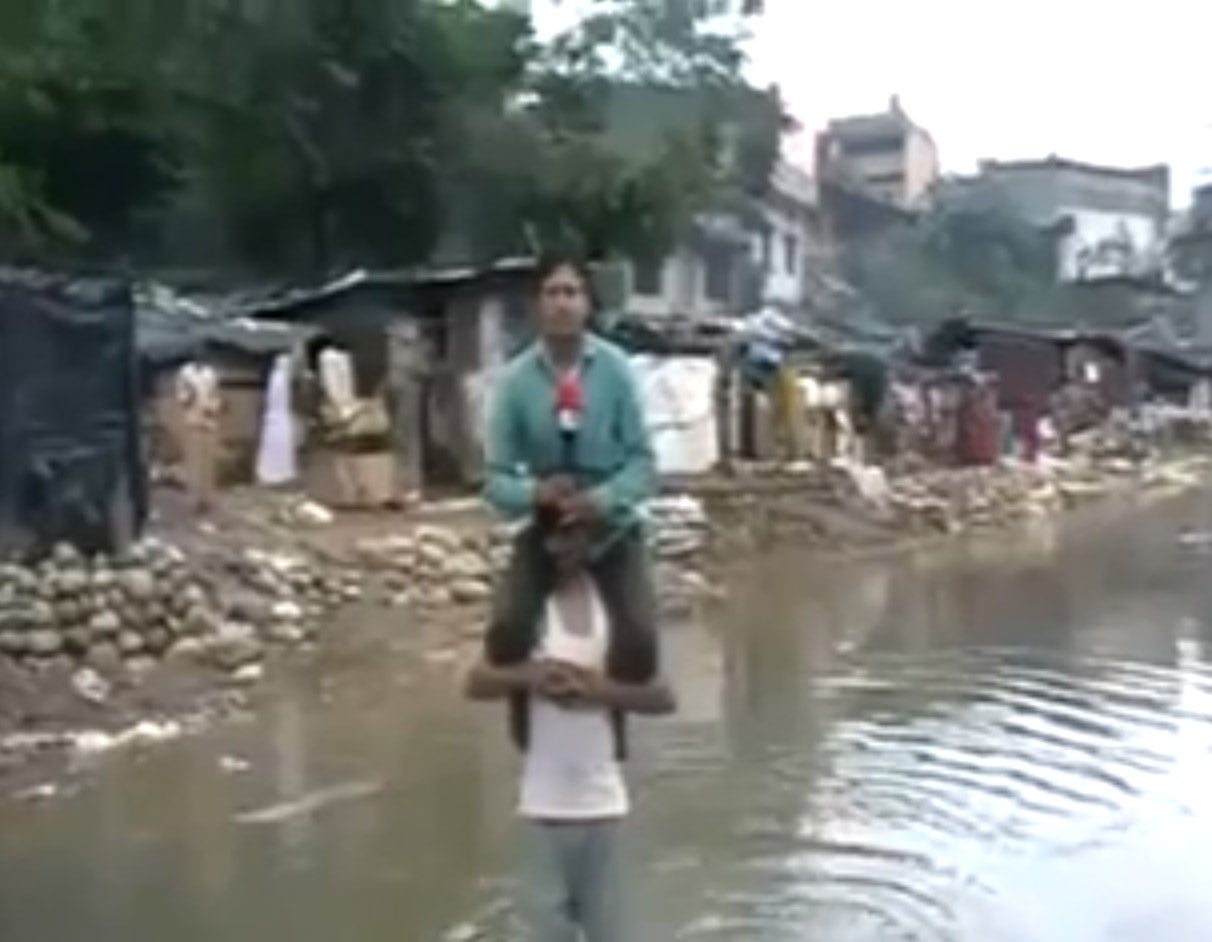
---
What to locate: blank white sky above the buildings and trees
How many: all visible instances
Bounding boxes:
[533,0,1212,205]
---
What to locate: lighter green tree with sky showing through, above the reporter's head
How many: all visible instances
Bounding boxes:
[458,0,785,257]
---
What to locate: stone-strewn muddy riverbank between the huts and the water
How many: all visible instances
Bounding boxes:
[0,451,1212,775]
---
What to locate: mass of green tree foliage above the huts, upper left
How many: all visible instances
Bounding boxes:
[0,0,782,276]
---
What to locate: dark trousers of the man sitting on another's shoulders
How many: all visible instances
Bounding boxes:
[485,526,659,753]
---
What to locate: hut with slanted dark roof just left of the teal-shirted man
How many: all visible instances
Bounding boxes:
[245,258,534,504]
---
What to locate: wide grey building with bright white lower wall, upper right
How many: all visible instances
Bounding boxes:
[964,156,1170,281]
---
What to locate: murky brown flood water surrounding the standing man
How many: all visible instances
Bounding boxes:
[0,499,1212,942]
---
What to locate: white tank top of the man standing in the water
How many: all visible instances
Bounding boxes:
[519,576,629,821]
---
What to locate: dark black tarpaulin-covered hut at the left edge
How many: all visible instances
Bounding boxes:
[0,269,147,555]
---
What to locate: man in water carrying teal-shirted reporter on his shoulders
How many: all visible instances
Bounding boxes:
[468,258,673,942]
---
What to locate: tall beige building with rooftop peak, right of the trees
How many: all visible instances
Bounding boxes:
[816,96,938,209]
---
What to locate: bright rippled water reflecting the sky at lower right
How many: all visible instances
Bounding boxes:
[662,649,1212,942]
